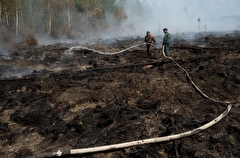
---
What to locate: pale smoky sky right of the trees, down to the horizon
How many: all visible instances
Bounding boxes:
[115,0,240,34]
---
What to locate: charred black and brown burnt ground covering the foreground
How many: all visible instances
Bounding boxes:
[0,33,240,158]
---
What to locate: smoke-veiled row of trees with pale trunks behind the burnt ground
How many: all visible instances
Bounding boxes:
[0,0,126,38]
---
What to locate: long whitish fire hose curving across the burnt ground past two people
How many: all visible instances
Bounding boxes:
[30,43,232,158]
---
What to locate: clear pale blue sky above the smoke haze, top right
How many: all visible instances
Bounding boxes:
[140,0,240,18]
